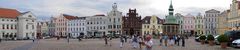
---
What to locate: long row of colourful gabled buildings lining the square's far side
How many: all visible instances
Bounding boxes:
[28,0,240,37]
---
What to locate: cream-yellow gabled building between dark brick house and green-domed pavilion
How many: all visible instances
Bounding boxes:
[141,16,164,35]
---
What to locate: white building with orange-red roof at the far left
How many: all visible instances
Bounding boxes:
[0,8,37,39]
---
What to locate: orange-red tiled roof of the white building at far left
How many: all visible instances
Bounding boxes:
[0,8,21,18]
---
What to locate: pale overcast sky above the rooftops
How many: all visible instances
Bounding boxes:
[0,0,232,18]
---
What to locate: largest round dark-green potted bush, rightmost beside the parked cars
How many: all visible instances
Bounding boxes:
[217,35,229,48]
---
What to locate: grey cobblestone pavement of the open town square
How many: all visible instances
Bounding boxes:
[0,38,240,50]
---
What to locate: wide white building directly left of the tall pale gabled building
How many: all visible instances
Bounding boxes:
[86,15,108,37]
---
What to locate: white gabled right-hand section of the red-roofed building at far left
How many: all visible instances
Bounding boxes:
[17,12,37,39]
